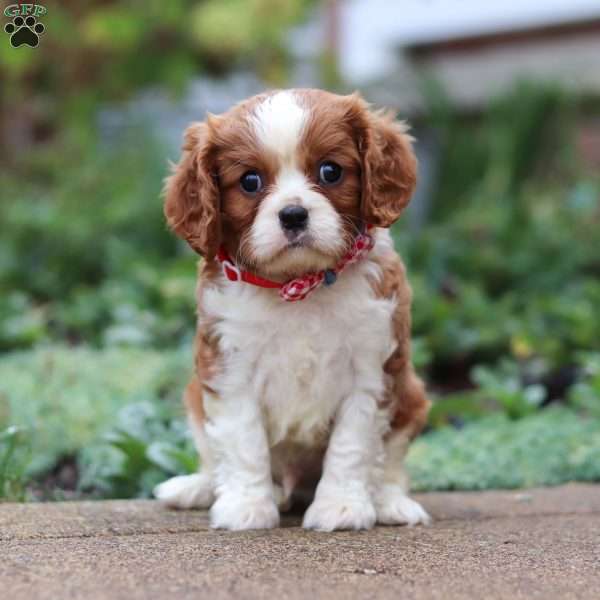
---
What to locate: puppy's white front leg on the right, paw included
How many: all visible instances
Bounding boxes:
[303,393,381,531]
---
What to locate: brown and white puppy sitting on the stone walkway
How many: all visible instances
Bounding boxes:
[155,90,429,531]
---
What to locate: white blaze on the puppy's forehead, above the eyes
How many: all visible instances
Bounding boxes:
[250,91,308,162]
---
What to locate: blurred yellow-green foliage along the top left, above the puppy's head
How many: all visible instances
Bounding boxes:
[0,0,313,160]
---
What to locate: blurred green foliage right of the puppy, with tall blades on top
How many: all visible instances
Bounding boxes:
[404,84,600,380]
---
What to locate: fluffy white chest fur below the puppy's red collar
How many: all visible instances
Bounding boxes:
[201,236,395,447]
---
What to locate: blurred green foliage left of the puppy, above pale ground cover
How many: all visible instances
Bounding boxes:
[0,137,195,349]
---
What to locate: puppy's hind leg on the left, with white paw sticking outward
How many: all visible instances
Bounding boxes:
[154,377,214,509]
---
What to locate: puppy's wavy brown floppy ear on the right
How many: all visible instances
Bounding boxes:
[355,96,417,227]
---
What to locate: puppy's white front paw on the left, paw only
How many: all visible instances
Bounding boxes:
[210,494,279,531]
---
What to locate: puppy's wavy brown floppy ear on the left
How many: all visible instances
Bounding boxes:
[164,123,221,258]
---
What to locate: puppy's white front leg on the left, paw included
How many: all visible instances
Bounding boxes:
[205,389,279,530]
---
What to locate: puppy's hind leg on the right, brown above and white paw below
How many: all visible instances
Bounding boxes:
[375,368,431,525]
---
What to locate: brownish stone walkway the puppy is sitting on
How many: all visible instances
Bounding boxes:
[0,484,600,600]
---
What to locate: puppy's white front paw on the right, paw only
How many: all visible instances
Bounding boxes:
[302,493,376,531]
